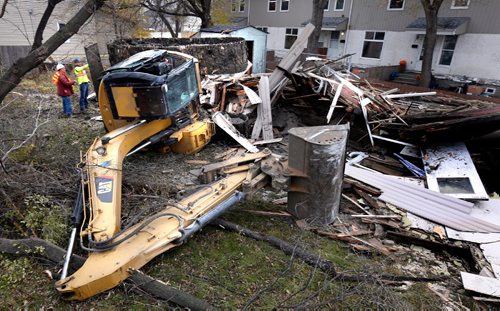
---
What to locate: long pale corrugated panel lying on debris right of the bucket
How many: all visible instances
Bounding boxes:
[345,165,500,232]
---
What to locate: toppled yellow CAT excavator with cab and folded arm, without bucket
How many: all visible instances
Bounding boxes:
[56,50,266,300]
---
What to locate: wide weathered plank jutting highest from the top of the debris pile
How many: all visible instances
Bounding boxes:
[269,23,315,92]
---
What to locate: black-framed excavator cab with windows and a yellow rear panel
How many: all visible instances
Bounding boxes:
[99,50,201,131]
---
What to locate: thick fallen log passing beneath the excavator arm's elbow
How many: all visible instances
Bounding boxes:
[0,238,214,310]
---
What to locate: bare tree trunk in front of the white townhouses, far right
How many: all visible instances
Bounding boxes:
[420,0,443,87]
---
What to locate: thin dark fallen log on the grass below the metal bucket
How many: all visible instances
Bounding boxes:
[211,219,445,284]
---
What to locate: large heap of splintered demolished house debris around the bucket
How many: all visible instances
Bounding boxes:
[189,27,500,300]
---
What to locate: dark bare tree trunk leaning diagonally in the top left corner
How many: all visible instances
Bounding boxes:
[0,0,105,103]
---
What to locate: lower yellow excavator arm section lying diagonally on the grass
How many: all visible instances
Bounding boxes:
[56,172,247,300]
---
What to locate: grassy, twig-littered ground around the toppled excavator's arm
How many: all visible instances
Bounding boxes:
[0,74,484,310]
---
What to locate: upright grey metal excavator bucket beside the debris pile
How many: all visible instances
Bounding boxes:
[288,124,349,225]
